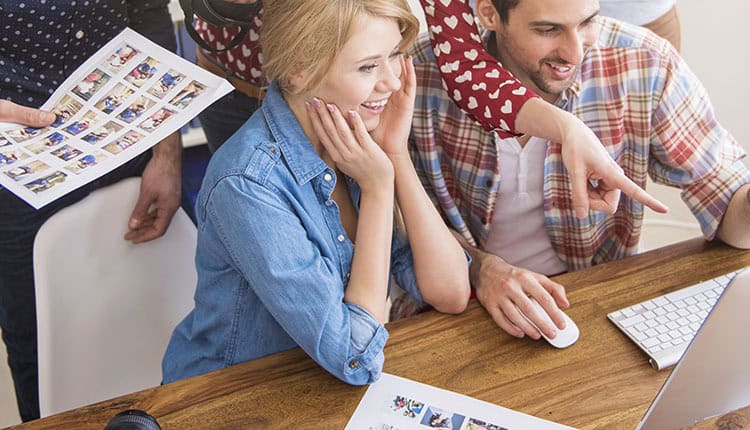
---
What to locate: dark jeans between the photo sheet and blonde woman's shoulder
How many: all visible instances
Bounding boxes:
[198,90,260,154]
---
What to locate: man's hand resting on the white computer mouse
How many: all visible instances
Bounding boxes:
[471,250,570,339]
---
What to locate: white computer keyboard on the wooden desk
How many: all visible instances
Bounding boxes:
[607,269,744,370]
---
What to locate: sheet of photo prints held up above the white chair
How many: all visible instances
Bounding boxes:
[0,29,232,209]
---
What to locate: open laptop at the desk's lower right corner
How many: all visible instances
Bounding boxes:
[638,270,750,430]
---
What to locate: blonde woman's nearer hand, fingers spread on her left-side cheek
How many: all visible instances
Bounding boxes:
[305,98,394,192]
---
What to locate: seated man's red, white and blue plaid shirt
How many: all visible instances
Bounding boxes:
[410,18,750,270]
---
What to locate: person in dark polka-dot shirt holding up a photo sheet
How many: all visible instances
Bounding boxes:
[0,0,182,421]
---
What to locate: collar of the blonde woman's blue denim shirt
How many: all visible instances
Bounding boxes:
[261,81,328,185]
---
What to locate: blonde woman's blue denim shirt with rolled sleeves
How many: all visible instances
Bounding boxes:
[162,85,422,385]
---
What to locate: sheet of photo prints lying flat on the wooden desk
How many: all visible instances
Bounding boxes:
[346,373,572,430]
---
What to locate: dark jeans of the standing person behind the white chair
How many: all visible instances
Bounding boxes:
[0,151,151,421]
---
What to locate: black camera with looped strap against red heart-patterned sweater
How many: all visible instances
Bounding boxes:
[180,0,262,52]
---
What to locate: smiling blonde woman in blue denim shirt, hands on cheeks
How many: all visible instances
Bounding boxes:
[163,0,469,384]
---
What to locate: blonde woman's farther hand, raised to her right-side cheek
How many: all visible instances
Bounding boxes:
[370,56,417,158]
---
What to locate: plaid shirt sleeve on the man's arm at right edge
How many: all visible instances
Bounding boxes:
[649,44,750,239]
